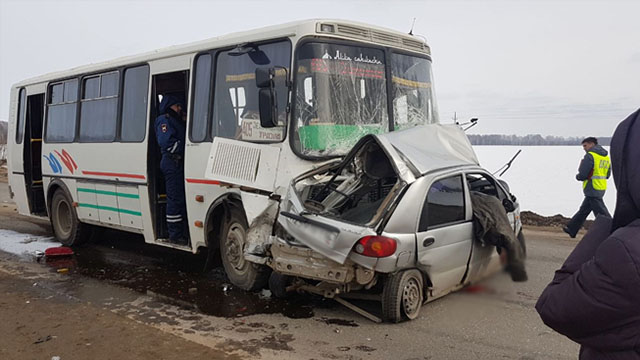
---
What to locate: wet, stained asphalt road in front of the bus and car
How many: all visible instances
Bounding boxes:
[0,183,578,359]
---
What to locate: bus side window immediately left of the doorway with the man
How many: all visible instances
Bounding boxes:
[120,65,149,141]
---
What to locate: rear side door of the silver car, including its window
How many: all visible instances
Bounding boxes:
[416,173,473,297]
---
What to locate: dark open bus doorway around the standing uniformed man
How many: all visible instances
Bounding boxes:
[147,70,189,239]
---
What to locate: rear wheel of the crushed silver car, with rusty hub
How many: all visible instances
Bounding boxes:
[382,269,424,323]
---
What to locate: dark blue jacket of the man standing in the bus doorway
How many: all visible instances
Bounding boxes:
[155,95,186,157]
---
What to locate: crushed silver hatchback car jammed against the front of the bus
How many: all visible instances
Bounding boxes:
[262,124,522,322]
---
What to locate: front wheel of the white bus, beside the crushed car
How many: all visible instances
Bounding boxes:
[220,207,269,290]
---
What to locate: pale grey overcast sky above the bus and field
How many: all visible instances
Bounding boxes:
[0,0,640,136]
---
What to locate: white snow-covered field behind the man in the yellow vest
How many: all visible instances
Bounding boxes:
[474,146,616,218]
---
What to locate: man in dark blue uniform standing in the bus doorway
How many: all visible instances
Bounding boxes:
[155,95,189,245]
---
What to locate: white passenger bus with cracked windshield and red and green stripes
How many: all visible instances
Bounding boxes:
[8,20,438,289]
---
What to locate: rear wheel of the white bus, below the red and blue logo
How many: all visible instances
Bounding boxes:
[51,189,91,246]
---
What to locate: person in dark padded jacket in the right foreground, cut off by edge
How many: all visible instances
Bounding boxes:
[536,110,640,360]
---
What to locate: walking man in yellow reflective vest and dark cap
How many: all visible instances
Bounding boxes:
[562,137,611,238]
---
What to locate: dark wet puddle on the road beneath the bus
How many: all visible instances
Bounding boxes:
[40,233,330,319]
